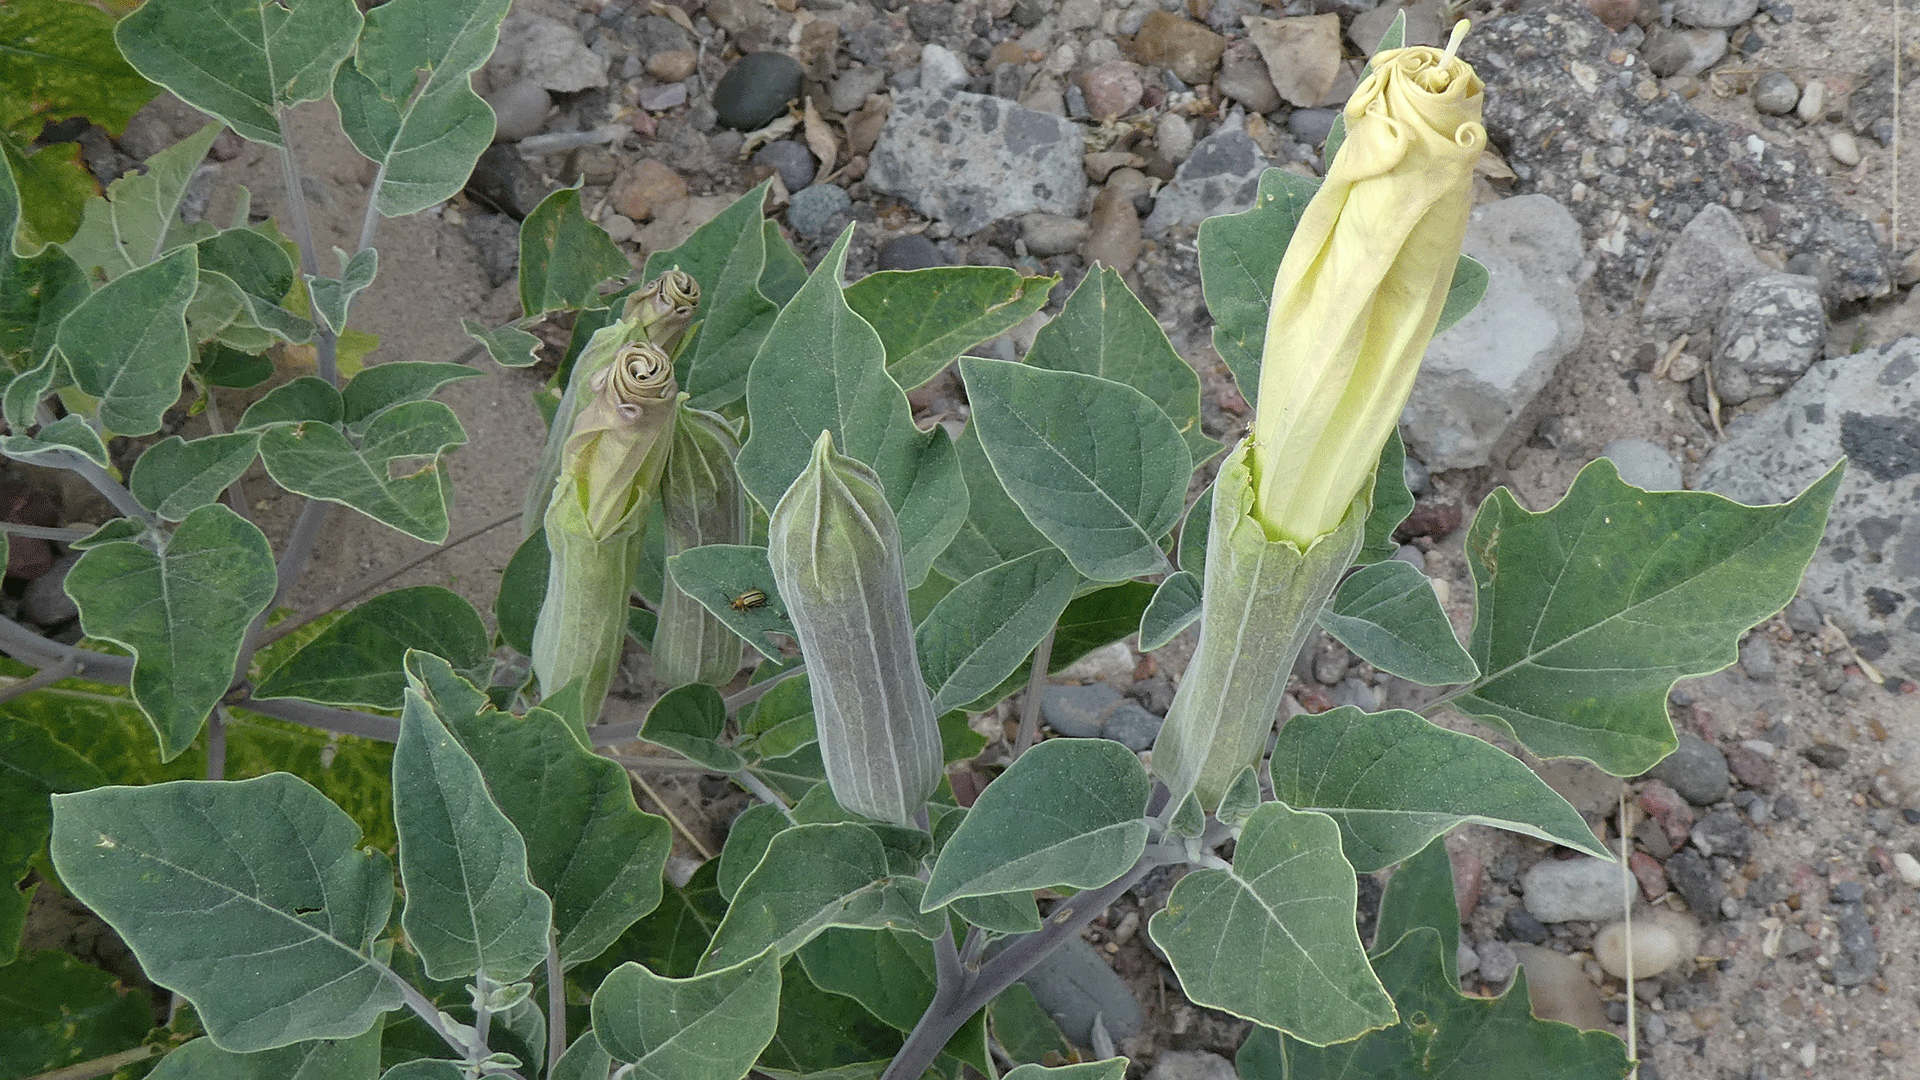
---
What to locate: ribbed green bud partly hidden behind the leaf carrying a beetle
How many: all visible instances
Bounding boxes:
[653,405,747,686]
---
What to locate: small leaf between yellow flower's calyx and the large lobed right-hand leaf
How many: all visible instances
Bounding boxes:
[1319,559,1480,686]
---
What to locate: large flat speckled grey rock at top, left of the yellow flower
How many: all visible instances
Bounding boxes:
[866,90,1087,236]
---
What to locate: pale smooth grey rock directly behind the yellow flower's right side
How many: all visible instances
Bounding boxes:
[1400,194,1586,469]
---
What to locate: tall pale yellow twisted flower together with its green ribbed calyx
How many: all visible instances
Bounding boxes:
[1154,23,1486,809]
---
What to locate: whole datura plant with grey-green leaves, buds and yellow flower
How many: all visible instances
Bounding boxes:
[11,12,1843,1080]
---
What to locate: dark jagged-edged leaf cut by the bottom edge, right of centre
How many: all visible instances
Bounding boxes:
[1235,926,1632,1080]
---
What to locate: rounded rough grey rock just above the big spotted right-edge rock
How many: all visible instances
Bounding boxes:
[1713,273,1826,405]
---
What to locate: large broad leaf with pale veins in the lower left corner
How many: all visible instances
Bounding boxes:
[50,773,401,1053]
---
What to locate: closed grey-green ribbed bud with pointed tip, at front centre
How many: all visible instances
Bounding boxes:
[766,432,941,824]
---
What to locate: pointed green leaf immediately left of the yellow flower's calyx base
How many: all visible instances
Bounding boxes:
[922,738,1150,911]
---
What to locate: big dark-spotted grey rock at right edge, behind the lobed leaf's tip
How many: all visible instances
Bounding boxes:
[1693,338,1920,678]
